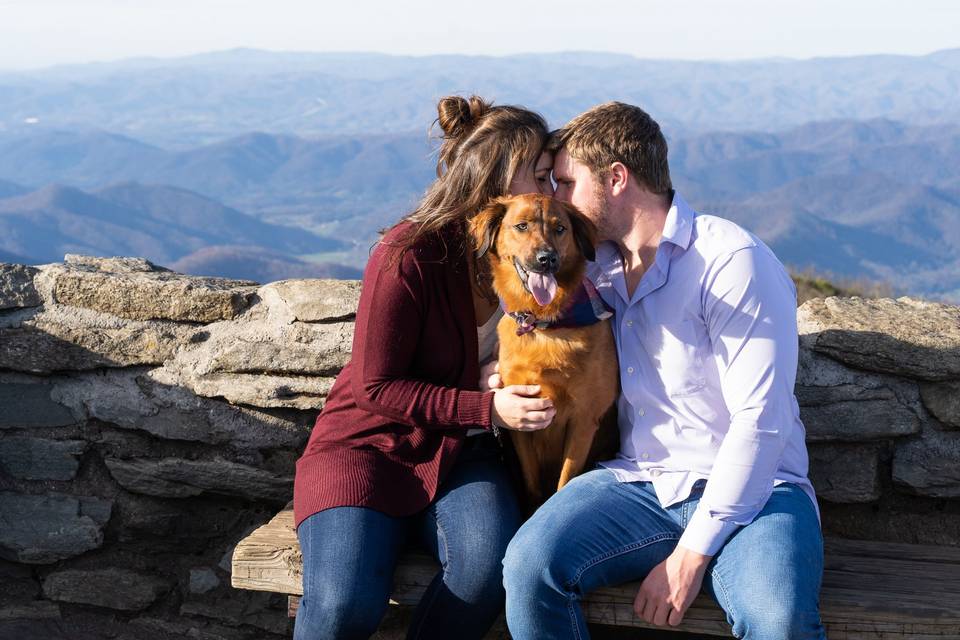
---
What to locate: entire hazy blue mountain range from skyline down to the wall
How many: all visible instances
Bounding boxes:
[0,50,960,301]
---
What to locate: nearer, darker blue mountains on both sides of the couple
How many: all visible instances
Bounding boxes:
[0,119,960,301]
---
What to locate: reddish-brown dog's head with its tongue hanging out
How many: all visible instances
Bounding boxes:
[470,194,597,317]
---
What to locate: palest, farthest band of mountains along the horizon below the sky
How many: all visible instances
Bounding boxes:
[0,49,960,148]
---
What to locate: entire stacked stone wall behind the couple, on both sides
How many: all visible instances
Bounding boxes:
[0,255,960,640]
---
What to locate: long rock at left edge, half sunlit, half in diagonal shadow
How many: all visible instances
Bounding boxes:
[0,303,197,373]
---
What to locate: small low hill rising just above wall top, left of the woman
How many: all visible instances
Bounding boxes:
[167,246,363,283]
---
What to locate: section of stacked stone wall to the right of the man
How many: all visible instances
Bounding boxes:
[796,298,960,546]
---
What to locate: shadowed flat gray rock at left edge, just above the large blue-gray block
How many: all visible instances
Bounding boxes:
[0,437,87,480]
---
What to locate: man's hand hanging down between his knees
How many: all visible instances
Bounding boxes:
[633,547,711,627]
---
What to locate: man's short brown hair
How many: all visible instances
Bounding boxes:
[549,102,673,193]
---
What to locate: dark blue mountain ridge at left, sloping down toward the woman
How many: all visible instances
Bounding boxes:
[0,184,346,264]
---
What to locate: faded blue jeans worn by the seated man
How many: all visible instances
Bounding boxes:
[503,469,825,640]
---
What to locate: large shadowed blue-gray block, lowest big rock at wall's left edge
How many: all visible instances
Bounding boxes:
[0,492,111,564]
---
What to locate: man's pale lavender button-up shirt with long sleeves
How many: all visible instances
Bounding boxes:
[588,194,816,555]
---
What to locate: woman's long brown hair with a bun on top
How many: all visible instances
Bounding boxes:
[382,96,549,255]
